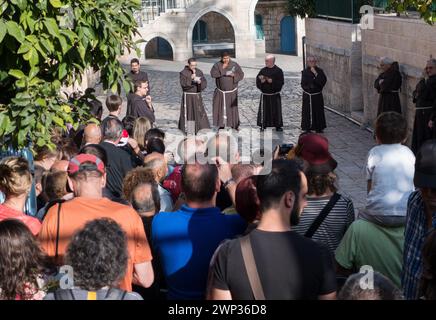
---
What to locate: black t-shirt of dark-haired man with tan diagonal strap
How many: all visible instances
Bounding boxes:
[212,229,336,300]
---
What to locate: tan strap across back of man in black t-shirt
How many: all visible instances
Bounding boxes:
[239,235,265,300]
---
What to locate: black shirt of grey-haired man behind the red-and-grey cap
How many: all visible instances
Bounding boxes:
[100,141,134,198]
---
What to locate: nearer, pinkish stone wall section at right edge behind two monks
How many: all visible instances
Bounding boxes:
[362,15,436,141]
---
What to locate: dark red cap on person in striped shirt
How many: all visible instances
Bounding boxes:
[297,133,338,174]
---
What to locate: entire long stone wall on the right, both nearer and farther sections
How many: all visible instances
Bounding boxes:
[306,1,436,140]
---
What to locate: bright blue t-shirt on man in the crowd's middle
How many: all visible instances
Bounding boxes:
[152,205,247,300]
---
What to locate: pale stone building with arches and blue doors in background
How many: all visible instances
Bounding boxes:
[129,0,304,61]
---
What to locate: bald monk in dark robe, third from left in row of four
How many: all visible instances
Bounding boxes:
[256,54,285,131]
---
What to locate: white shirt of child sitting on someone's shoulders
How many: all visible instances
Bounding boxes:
[364,144,415,217]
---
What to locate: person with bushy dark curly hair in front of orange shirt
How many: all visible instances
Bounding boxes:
[45,218,142,300]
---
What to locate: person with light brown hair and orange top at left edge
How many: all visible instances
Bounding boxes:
[0,157,41,235]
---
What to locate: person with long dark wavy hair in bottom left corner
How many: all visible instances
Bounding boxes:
[0,219,48,300]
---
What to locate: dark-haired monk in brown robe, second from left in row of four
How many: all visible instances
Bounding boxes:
[210,53,244,129]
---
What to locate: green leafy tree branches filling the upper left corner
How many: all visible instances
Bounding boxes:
[0,0,140,147]
